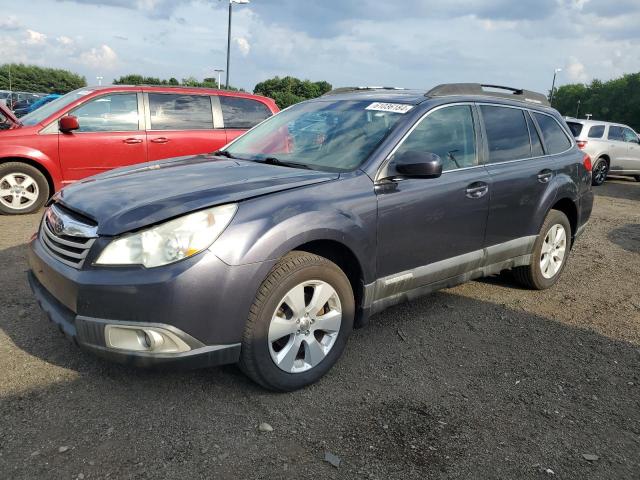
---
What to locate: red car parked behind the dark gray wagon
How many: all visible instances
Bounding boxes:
[0,86,278,214]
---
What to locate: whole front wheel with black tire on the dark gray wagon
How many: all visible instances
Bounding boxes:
[240,251,355,392]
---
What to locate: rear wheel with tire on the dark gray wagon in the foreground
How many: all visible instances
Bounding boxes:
[513,210,571,290]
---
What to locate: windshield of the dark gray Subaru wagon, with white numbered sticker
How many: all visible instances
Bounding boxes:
[225,100,412,171]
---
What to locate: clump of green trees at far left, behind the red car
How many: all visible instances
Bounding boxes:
[0,63,87,93]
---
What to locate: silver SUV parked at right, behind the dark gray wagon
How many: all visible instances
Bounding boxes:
[567,118,640,185]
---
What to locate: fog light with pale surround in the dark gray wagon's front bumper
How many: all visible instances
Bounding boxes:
[104,325,191,353]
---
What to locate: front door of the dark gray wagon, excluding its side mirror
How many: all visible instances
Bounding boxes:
[376,104,490,297]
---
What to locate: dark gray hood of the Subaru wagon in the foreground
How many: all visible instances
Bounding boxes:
[54,155,339,235]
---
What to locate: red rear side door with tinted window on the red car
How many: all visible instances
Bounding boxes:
[145,92,227,160]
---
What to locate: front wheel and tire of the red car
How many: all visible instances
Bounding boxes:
[0,162,49,215]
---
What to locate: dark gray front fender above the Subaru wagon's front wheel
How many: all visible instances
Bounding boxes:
[211,174,377,282]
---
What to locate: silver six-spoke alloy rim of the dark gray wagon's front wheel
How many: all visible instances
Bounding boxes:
[268,280,342,373]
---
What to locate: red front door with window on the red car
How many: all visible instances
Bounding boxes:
[58,92,147,183]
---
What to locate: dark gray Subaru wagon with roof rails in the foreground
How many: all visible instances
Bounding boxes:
[29,84,593,391]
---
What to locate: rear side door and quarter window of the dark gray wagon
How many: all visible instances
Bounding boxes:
[479,104,571,256]
